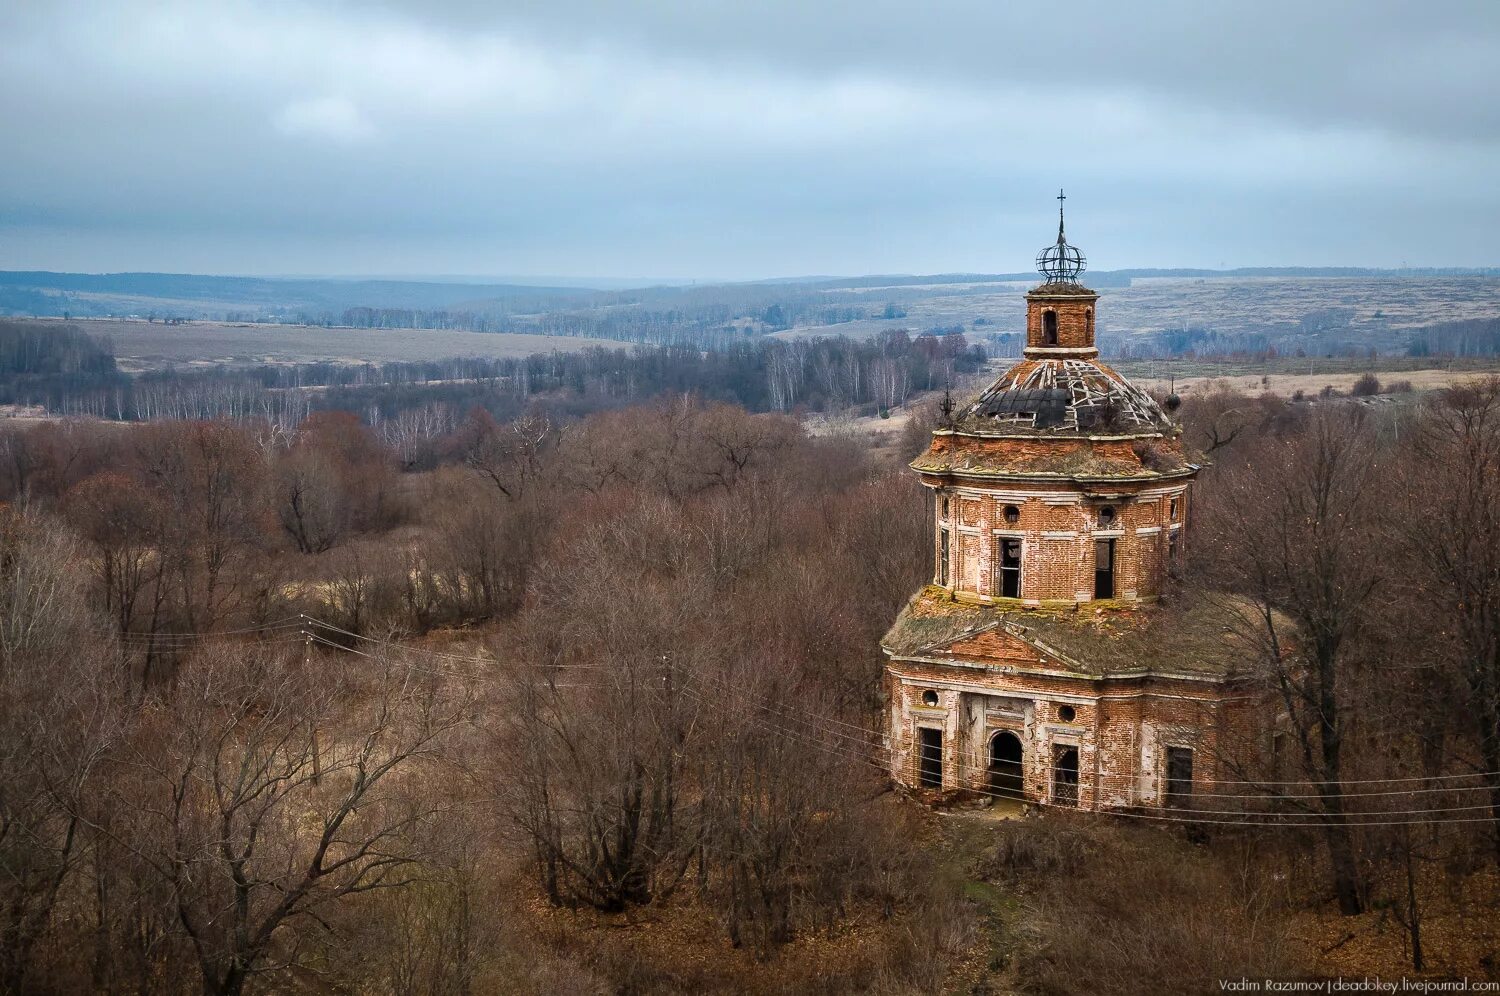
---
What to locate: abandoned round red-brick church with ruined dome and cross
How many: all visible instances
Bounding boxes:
[882,196,1265,809]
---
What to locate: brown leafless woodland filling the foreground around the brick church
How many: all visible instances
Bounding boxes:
[0,369,1500,993]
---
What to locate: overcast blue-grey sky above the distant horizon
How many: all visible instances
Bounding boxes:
[0,0,1500,281]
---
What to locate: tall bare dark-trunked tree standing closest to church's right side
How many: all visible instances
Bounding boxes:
[1200,410,1382,915]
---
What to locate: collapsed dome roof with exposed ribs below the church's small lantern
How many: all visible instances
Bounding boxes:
[954,359,1173,434]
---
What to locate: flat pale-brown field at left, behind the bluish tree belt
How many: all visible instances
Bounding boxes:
[0,318,627,372]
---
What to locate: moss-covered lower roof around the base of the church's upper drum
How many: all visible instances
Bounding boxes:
[882,587,1290,677]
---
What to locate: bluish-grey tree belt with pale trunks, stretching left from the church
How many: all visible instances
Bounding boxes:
[0,324,986,428]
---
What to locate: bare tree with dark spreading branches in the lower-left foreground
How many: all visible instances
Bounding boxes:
[95,645,464,996]
